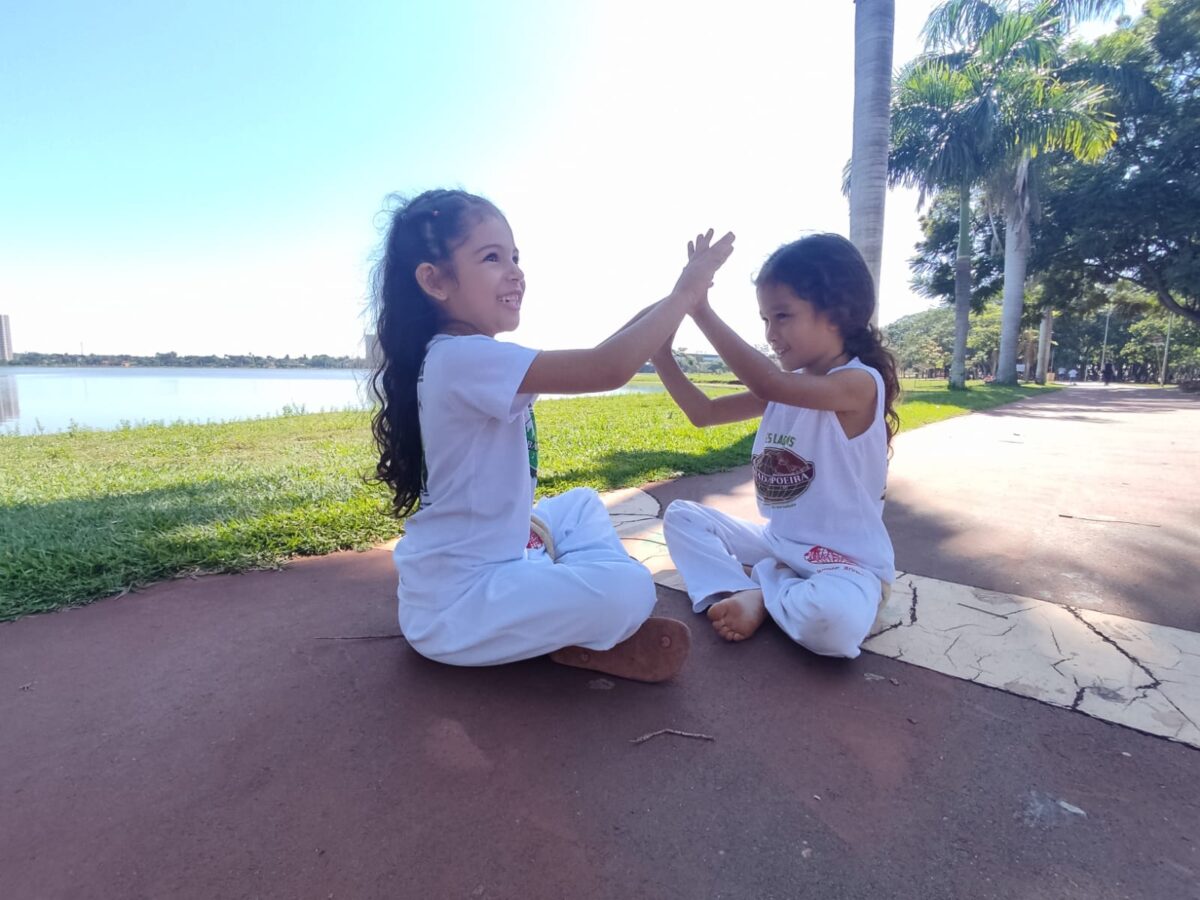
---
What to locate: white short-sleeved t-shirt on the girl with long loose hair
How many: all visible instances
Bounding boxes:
[395,335,538,602]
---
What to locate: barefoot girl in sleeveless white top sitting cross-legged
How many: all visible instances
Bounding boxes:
[653,234,900,658]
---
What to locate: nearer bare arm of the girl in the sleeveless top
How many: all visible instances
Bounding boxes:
[692,304,875,413]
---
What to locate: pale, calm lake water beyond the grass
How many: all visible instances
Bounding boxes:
[0,366,661,434]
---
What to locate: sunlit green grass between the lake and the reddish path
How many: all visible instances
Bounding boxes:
[0,376,1060,622]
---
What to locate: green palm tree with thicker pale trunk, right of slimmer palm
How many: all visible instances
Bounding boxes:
[925,0,1122,383]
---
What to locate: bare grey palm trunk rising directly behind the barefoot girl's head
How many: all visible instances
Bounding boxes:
[850,0,895,322]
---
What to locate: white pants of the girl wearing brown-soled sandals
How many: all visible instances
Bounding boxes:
[400,487,655,666]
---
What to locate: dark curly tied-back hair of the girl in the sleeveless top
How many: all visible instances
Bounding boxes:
[755,234,900,446]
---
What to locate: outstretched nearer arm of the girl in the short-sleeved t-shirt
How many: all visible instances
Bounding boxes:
[521,232,733,394]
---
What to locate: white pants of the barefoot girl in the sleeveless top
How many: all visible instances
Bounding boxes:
[662,500,883,659]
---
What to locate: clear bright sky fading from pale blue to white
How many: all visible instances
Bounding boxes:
[0,0,1132,356]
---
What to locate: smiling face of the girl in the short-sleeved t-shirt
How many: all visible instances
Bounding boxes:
[416,215,524,337]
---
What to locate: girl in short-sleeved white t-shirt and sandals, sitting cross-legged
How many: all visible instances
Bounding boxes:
[373,191,733,682]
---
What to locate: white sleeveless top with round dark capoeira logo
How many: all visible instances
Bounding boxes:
[751,356,895,583]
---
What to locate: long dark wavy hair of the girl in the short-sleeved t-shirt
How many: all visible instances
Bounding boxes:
[371,190,504,516]
